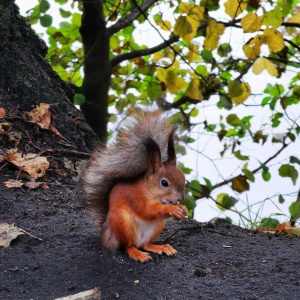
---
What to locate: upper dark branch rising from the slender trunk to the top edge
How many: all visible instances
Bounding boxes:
[107,0,158,36]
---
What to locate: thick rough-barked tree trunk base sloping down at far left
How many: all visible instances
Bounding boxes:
[0,0,99,153]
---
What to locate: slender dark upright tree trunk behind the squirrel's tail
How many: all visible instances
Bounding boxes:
[80,0,111,143]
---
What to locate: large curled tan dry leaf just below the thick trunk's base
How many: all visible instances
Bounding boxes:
[6,149,50,178]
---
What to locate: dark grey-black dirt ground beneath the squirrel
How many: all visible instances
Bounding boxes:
[0,166,300,300]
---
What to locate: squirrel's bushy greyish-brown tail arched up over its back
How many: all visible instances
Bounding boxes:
[82,109,174,225]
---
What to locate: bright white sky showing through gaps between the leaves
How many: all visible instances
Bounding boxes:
[16,0,300,222]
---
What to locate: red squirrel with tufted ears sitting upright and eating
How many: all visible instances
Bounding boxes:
[82,109,187,262]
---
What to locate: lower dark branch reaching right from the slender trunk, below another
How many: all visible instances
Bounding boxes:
[110,35,179,68]
